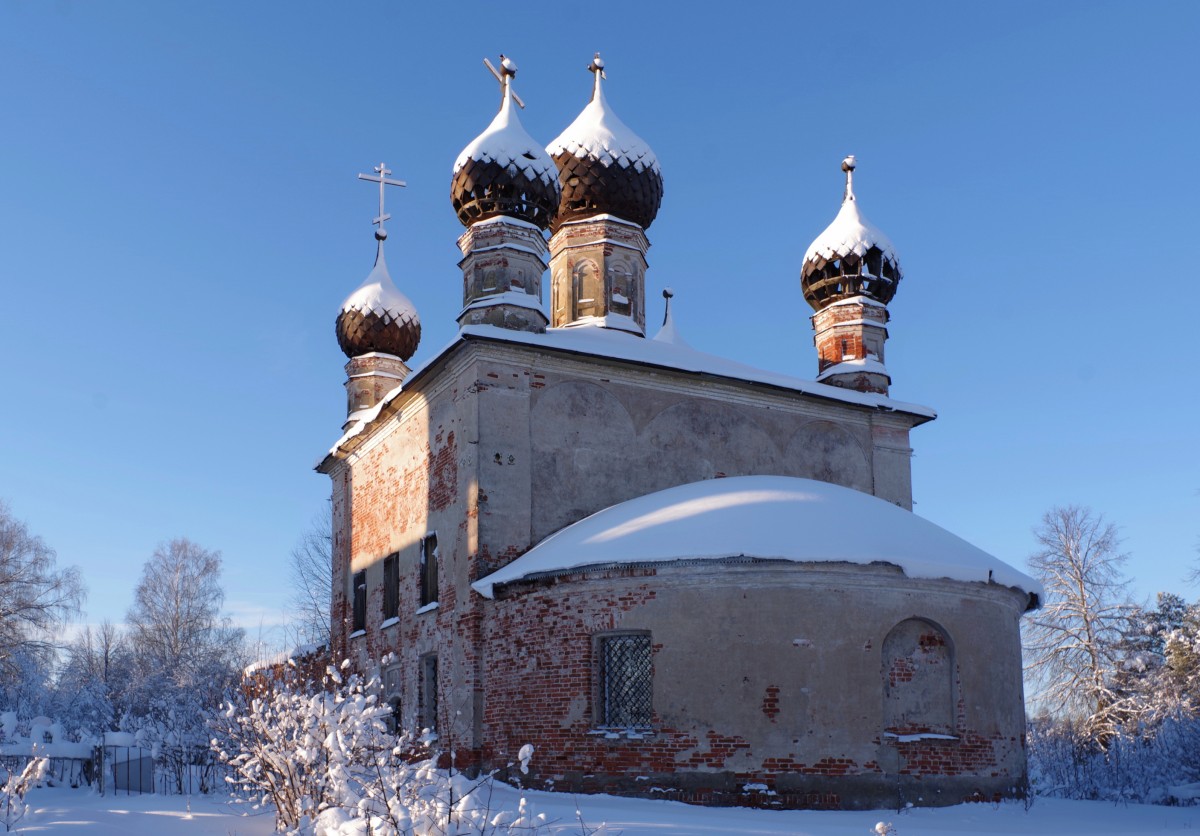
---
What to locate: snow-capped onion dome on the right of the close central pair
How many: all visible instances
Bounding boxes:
[546,53,662,229]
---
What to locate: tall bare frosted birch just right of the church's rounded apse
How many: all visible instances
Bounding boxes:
[1025,505,1133,747]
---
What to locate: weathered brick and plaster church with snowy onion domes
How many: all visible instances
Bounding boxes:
[318,55,1042,808]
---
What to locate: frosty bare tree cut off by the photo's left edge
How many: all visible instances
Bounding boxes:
[0,503,84,678]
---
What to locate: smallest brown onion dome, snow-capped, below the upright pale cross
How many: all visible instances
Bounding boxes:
[337,229,421,361]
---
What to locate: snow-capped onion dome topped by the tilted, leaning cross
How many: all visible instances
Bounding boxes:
[450,55,559,229]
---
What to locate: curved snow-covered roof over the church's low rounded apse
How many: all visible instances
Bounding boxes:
[472,476,1044,600]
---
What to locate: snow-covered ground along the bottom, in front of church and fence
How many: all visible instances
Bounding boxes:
[17,788,1200,836]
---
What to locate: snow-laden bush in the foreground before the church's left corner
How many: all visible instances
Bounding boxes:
[212,662,607,836]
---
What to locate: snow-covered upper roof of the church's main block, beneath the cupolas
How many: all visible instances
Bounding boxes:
[317,325,937,468]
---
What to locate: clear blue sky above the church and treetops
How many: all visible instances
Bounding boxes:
[0,0,1200,631]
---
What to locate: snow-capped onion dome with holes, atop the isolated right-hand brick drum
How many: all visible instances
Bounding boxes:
[800,155,900,311]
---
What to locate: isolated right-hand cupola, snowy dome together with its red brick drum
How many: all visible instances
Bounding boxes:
[800,155,900,395]
